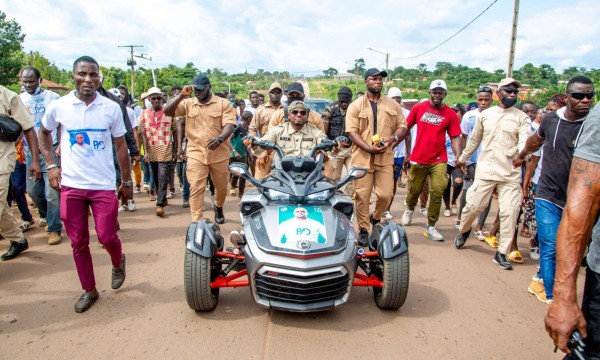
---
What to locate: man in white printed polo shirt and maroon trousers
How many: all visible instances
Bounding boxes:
[39,56,132,313]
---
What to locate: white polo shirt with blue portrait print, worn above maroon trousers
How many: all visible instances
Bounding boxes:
[42,92,125,190]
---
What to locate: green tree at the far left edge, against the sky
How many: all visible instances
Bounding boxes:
[0,11,25,84]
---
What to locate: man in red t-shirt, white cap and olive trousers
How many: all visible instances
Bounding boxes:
[402,80,462,241]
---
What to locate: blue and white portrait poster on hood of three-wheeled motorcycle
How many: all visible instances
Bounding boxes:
[278,206,327,250]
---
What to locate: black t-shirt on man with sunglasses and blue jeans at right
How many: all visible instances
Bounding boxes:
[535,108,585,208]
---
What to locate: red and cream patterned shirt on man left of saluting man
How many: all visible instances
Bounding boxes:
[139,109,177,162]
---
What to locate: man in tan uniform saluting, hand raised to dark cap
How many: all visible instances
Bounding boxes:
[164,74,236,224]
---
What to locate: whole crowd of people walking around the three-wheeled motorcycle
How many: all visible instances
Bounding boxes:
[0,56,600,354]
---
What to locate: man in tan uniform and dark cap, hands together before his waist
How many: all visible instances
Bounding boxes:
[346,68,406,246]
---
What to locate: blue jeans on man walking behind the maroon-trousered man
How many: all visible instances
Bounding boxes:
[26,145,62,233]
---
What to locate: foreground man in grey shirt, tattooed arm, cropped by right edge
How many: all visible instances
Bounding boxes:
[545,100,600,359]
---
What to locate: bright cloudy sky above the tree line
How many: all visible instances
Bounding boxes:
[0,0,600,76]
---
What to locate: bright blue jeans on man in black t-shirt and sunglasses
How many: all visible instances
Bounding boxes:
[535,199,563,300]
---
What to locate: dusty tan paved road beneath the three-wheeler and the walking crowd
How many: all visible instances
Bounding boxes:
[0,184,580,359]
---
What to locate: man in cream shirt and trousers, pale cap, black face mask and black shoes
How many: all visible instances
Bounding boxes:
[454,78,530,270]
